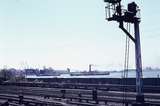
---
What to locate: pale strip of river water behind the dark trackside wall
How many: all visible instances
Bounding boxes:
[26,70,160,78]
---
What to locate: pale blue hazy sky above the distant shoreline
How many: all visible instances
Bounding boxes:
[0,0,160,70]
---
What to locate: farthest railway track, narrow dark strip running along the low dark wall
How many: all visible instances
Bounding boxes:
[0,82,160,93]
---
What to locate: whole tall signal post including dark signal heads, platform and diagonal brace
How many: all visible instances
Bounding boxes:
[104,0,144,105]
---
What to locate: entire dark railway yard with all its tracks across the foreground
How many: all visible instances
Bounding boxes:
[0,83,160,106]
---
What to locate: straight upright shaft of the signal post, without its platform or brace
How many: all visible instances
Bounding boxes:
[134,20,144,103]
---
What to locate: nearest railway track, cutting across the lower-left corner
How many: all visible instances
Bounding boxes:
[0,86,69,106]
